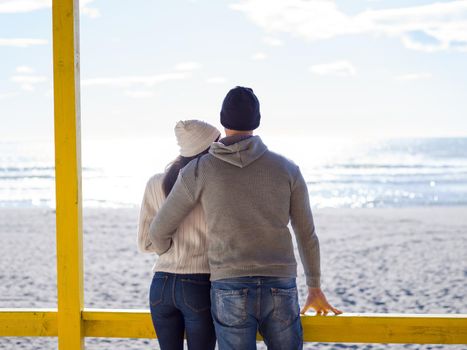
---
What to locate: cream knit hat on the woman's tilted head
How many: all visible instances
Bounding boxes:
[174,120,221,157]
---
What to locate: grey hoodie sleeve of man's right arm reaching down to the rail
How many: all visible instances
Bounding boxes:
[290,167,321,288]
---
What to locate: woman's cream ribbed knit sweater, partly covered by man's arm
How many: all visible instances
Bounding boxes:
[138,174,209,274]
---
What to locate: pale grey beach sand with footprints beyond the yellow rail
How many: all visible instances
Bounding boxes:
[0,207,467,350]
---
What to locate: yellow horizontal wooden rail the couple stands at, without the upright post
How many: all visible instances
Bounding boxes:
[0,309,467,344]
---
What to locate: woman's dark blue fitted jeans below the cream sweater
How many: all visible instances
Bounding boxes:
[149,272,216,350]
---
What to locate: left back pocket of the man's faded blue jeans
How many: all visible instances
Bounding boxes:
[213,288,248,327]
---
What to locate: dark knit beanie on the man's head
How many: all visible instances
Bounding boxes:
[221,86,261,131]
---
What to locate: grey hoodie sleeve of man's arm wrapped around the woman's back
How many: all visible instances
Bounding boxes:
[149,175,196,255]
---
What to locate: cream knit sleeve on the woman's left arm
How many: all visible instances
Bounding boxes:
[137,177,159,253]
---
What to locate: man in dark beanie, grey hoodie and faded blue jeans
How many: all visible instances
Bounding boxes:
[150,87,341,350]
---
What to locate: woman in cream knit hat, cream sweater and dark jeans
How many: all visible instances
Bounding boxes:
[138,120,220,350]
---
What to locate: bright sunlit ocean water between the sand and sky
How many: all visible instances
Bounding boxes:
[0,137,467,208]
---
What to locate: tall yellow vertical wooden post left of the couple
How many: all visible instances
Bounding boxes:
[52,0,84,350]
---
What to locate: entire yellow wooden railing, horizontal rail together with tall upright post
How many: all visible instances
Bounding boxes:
[0,0,467,350]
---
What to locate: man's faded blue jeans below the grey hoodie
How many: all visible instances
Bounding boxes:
[211,277,303,350]
